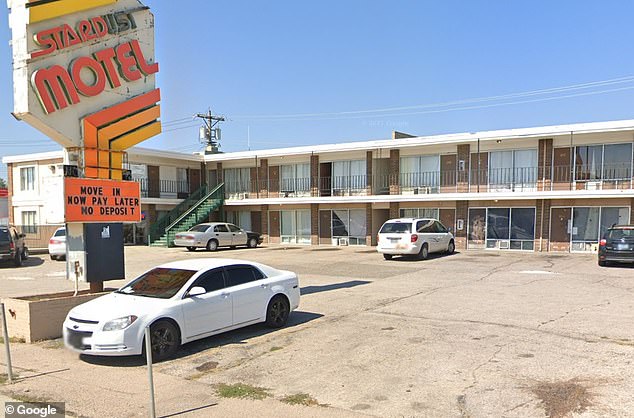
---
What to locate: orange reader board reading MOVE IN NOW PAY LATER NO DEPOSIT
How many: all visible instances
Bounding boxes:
[64,178,141,223]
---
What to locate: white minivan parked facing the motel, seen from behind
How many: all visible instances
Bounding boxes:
[377,218,456,260]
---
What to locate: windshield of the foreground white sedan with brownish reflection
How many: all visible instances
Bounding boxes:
[117,267,196,299]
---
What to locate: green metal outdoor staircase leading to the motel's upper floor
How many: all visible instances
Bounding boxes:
[148,183,225,247]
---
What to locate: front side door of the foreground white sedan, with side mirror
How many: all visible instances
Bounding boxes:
[182,269,233,339]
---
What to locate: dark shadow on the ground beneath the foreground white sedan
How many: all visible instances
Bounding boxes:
[79,311,323,367]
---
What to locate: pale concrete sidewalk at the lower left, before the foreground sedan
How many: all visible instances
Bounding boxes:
[0,341,361,418]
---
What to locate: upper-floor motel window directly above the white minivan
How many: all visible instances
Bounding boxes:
[400,155,440,194]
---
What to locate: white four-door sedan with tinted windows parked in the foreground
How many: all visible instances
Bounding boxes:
[63,258,300,361]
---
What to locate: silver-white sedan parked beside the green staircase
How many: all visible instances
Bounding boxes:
[174,222,262,251]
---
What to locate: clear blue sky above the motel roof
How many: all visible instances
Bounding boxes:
[0,0,634,179]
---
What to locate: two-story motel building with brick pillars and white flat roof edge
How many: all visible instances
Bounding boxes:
[2,120,634,252]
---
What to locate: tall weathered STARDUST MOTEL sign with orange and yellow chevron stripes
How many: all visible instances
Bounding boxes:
[7,0,161,155]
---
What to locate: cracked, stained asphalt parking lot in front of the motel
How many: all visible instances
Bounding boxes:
[0,246,634,417]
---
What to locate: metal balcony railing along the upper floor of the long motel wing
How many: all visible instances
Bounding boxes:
[217,164,634,199]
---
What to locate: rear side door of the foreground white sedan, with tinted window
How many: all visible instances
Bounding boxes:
[225,265,271,325]
